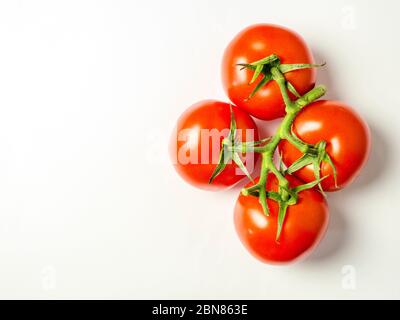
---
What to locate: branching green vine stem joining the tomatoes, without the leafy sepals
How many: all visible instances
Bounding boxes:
[242,67,326,208]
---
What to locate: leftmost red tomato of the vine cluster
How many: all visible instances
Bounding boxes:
[170,100,258,190]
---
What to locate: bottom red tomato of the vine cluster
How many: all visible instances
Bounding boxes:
[234,174,329,264]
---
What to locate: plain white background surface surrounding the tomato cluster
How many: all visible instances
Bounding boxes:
[0,0,400,299]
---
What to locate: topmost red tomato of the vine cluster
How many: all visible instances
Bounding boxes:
[222,24,316,120]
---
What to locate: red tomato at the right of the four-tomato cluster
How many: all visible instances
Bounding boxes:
[279,100,371,191]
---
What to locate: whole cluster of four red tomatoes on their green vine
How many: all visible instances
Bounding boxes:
[170,24,370,264]
